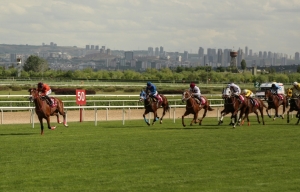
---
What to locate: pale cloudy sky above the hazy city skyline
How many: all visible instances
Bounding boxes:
[0,0,300,56]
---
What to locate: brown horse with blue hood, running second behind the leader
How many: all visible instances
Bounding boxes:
[139,90,170,125]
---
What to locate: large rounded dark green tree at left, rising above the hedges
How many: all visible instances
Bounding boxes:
[23,55,48,72]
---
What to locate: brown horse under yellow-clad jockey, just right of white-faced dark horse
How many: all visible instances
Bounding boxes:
[232,96,267,128]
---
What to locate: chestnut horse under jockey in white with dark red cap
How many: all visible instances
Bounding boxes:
[181,90,214,127]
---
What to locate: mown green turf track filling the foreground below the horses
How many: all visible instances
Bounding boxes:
[0,117,300,192]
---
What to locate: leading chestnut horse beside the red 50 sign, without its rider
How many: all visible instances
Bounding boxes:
[28,88,68,135]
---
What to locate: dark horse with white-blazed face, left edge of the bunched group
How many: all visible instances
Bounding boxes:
[218,87,237,125]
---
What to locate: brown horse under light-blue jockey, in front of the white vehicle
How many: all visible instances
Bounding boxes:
[265,89,288,121]
